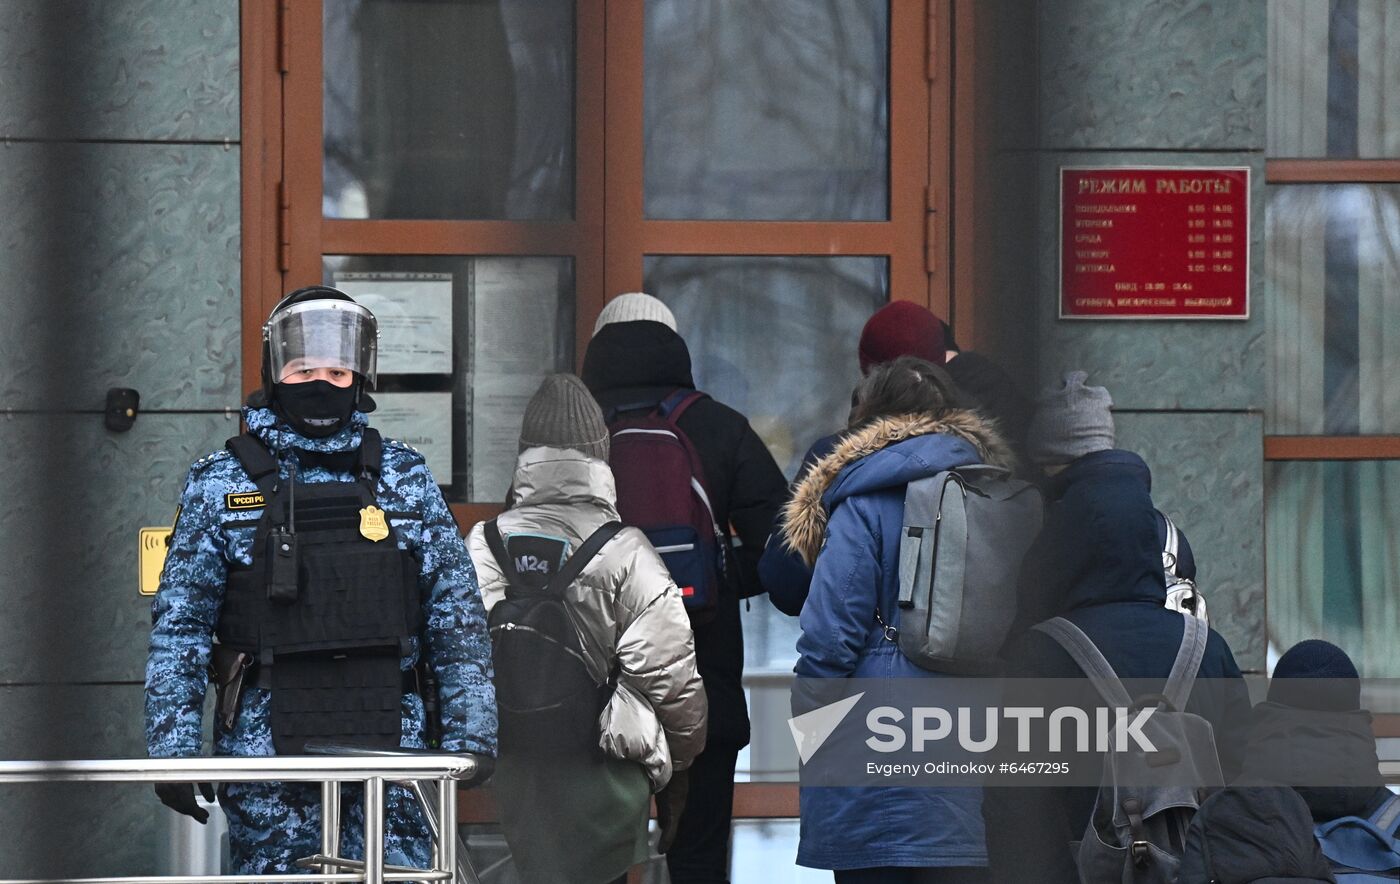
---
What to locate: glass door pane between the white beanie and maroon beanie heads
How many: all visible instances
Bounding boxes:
[644,255,889,476]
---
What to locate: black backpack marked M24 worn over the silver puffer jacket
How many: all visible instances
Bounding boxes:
[483,520,622,754]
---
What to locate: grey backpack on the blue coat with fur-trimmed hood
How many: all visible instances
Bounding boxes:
[876,464,1043,672]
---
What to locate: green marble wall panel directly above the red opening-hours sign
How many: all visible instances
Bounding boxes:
[1039,0,1268,150]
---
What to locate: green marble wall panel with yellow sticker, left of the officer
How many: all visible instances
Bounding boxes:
[0,413,238,683]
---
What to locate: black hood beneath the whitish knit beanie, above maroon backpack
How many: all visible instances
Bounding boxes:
[582,321,696,409]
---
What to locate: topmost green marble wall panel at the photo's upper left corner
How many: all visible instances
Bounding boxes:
[0,0,239,141]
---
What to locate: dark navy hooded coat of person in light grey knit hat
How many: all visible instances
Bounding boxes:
[983,450,1250,884]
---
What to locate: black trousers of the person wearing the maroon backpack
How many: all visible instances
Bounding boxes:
[666,745,739,884]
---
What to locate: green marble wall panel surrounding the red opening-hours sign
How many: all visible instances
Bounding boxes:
[1036,153,1268,410]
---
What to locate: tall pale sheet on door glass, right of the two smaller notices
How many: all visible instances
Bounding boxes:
[468,258,560,502]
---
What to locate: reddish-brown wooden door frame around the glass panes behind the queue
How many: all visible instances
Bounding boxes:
[241,0,995,846]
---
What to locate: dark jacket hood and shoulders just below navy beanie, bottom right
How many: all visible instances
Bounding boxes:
[1243,702,1390,822]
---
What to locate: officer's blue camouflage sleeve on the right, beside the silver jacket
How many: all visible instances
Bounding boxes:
[413,468,496,757]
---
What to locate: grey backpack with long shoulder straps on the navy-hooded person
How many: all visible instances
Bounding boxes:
[1035,615,1225,884]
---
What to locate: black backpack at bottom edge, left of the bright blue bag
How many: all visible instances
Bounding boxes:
[1176,785,1336,884]
